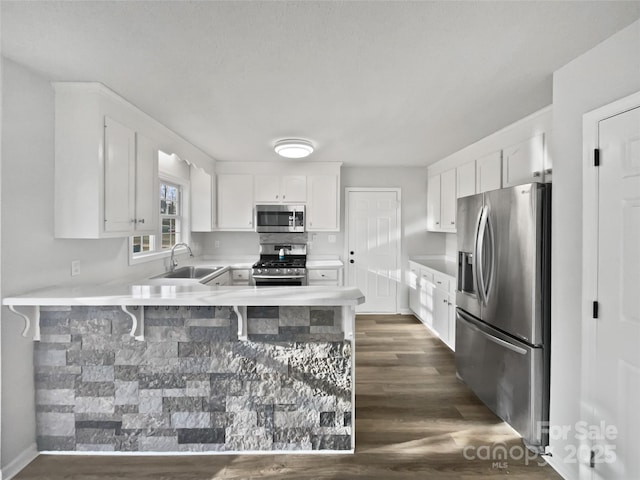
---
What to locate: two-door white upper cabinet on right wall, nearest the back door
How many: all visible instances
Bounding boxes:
[427,168,457,232]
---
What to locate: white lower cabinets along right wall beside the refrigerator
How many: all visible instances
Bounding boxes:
[408,262,456,350]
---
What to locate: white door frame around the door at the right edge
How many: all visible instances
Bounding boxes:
[580,92,640,475]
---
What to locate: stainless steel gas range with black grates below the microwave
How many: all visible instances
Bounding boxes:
[251,243,307,286]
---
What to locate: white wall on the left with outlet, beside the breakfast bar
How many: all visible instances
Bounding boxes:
[0,59,200,469]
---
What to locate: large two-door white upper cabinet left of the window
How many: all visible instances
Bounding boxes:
[54,84,158,238]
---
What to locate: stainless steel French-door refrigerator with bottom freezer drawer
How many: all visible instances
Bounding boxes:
[455,183,551,451]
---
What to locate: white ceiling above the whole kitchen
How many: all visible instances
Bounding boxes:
[1,0,640,166]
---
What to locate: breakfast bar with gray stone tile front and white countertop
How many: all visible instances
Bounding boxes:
[3,284,364,454]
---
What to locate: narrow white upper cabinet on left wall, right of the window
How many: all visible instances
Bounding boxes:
[190,165,216,232]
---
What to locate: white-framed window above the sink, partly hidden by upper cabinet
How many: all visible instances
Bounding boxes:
[130,178,184,259]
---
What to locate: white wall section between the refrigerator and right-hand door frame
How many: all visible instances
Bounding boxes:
[550,21,640,478]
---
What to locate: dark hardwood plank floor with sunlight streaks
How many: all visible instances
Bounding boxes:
[15,315,561,480]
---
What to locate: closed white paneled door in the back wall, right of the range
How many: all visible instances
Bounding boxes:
[346,189,400,313]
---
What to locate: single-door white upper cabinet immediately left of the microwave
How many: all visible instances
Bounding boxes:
[218,174,255,231]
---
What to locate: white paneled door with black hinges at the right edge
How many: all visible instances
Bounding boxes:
[591,104,640,479]
